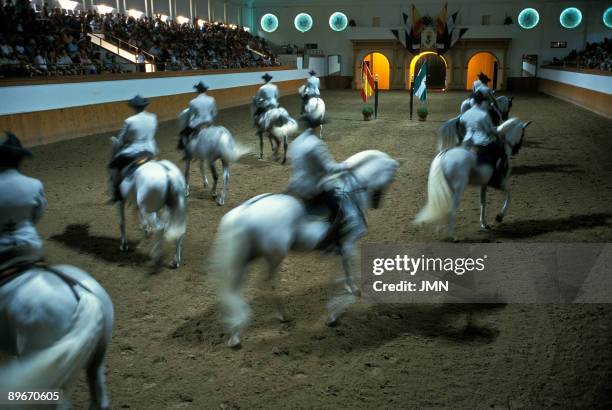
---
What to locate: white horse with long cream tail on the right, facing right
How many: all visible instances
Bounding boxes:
[414,118,531,240]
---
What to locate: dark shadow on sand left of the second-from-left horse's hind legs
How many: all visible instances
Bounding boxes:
[49,224,149,264]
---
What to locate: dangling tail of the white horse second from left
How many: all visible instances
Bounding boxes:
[161,161,187,241]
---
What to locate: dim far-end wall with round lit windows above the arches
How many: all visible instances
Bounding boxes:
[253,0,612,77]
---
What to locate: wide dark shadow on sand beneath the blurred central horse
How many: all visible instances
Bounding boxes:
[168,280,506,357]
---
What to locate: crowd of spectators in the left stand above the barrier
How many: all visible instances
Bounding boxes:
[0,0,279,78]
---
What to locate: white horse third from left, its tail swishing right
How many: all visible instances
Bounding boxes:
[179,109,249,206]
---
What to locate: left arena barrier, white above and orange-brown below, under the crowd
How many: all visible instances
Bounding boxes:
[0,68,308,145]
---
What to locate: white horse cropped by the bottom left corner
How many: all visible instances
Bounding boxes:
[0,265,114,409]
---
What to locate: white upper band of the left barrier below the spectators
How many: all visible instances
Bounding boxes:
[0,70,309,115]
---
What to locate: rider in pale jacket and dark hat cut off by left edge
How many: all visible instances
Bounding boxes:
[0,133,47,276]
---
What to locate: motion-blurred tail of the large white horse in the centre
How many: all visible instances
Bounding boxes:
[210,207,251,334]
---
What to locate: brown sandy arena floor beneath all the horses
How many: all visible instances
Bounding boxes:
[16,91,612,409]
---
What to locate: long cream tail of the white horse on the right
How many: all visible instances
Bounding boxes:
[414,153,453,224]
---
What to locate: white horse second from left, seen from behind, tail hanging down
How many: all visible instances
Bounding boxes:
[111,137,187,268]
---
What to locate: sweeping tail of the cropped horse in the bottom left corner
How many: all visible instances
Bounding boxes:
[0,292,104,390]
